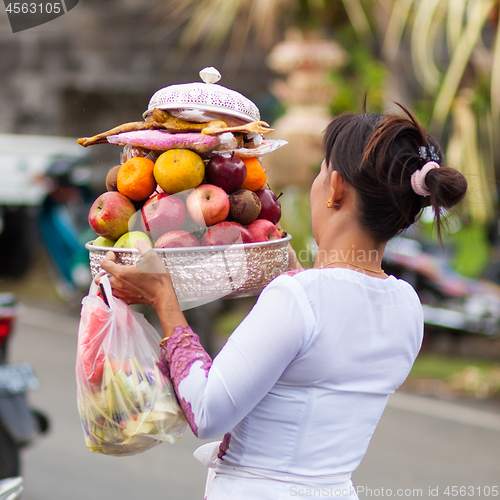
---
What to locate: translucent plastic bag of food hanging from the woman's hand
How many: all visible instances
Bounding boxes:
[76,276,186,455]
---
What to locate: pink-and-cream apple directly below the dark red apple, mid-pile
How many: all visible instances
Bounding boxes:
[186,184,229,226]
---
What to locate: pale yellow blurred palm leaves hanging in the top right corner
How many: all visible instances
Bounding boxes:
[382,0,500,128]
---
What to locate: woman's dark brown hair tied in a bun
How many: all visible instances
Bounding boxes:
[324,104,467,242]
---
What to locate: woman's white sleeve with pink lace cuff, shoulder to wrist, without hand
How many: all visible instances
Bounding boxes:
[165,276,315,439]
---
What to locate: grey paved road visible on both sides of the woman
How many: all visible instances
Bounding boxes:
[7,308,500,500]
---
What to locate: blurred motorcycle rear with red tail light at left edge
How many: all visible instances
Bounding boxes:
[0,293,49,480]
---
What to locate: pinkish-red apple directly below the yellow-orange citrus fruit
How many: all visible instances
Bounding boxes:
[141,193,187,240]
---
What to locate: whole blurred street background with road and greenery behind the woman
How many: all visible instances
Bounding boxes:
[0,0,500,500]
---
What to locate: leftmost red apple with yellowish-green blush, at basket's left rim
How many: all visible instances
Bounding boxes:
[89,191,135,240]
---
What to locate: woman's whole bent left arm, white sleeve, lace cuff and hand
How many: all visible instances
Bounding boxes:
[101,248,315,438]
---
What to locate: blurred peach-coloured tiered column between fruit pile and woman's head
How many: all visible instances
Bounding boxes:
[266,30,348,190]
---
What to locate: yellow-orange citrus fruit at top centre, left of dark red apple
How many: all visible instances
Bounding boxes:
[153,149,205,194]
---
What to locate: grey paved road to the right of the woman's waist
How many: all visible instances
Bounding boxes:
[354,394,500,499]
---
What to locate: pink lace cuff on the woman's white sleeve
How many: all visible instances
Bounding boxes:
[159,326,212,436]
